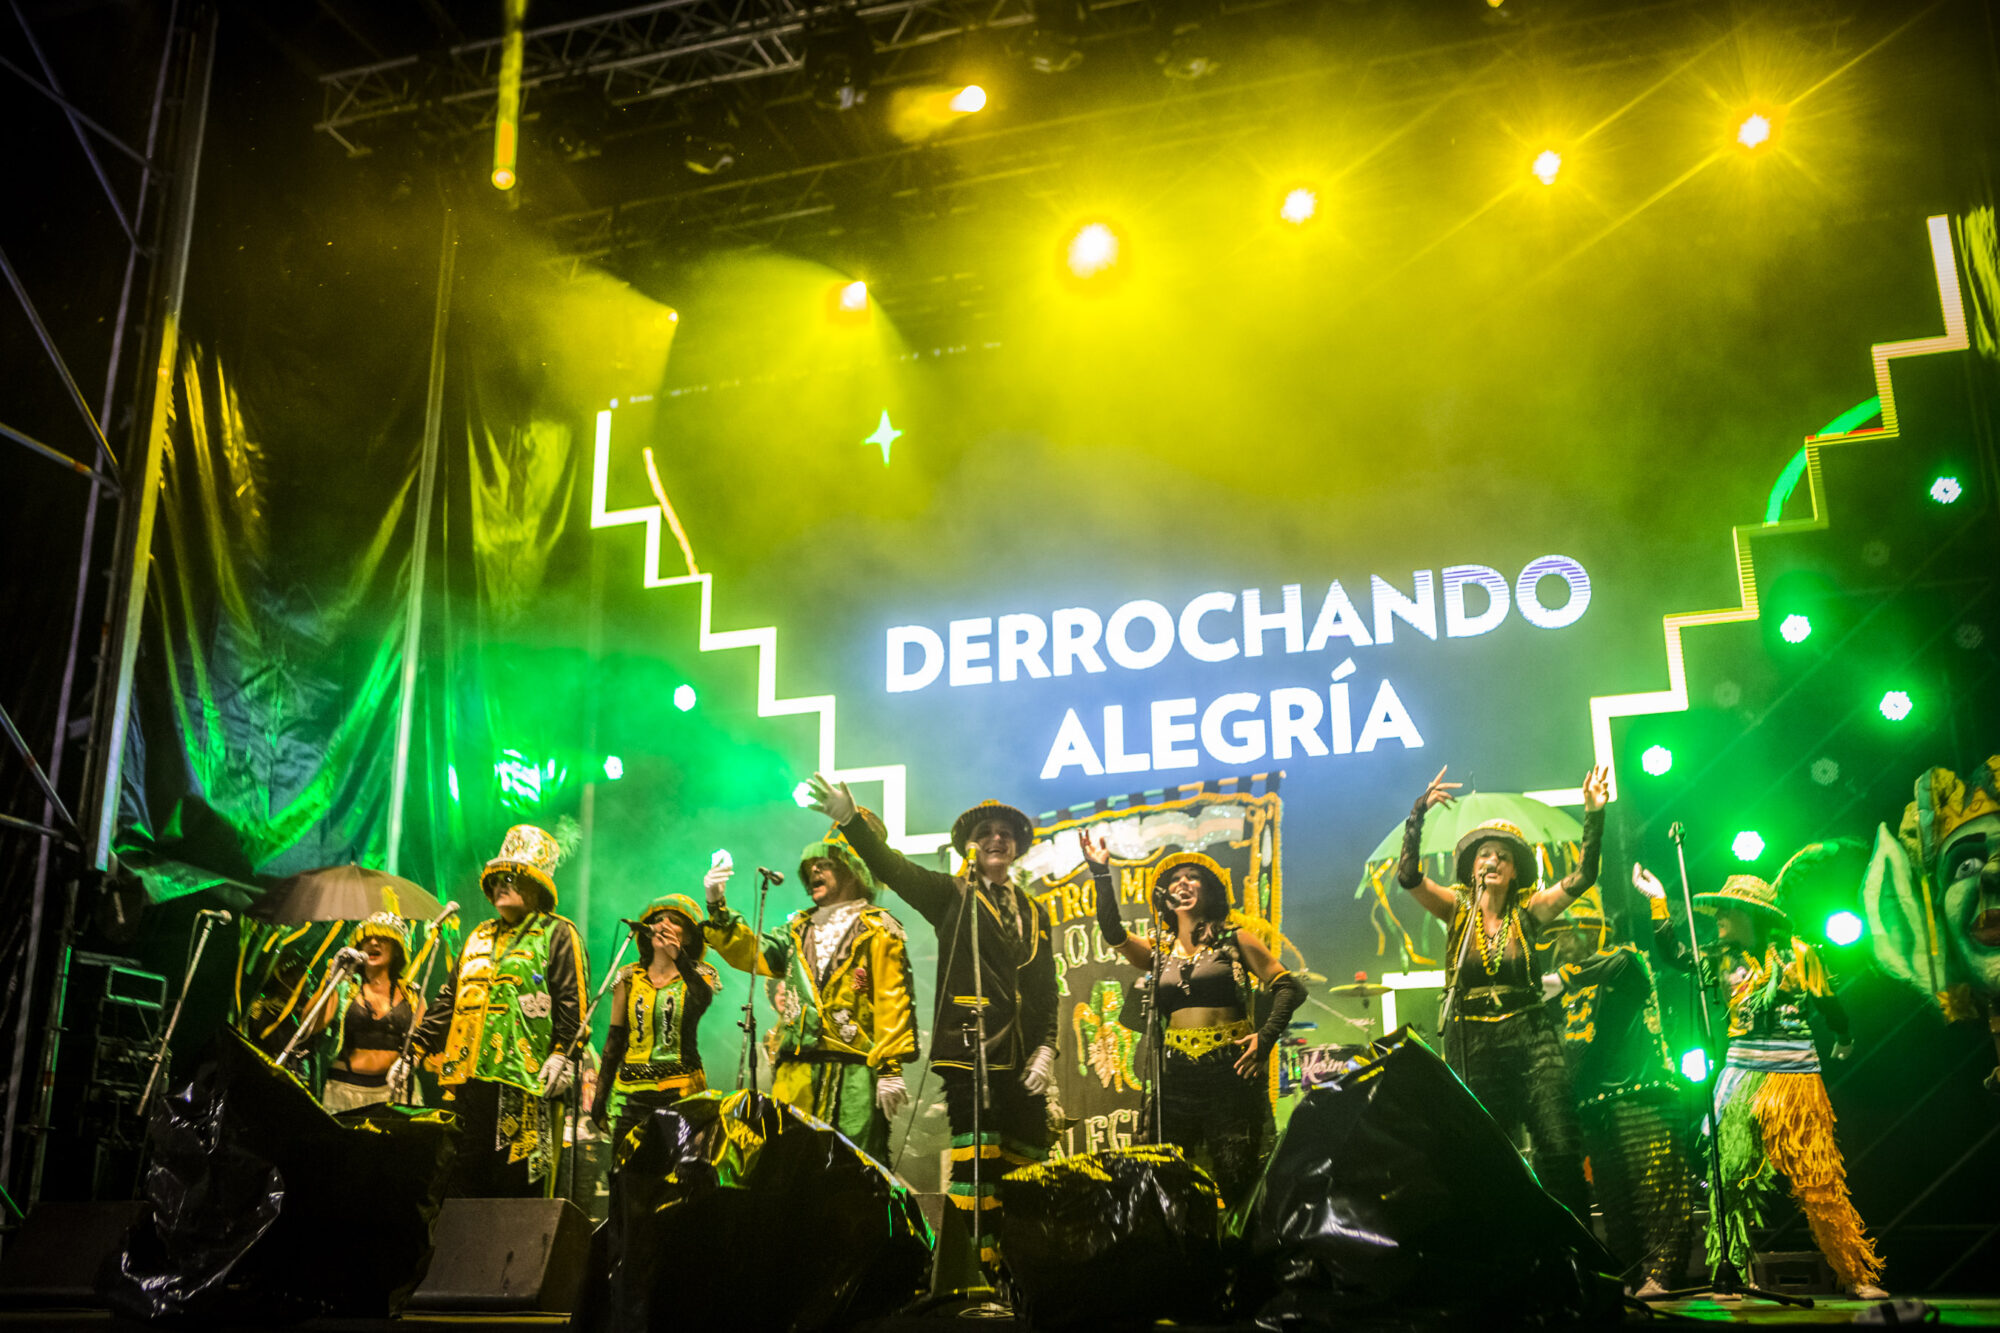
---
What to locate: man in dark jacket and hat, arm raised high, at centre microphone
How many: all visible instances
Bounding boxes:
[810,773,1056,1265]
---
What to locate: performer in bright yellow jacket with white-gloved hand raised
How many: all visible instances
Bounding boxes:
[704,808,916,1161]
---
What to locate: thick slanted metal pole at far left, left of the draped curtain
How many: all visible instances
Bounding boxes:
[82,10,216,871]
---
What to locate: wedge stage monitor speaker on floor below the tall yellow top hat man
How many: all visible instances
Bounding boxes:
[410,1199,590,1313]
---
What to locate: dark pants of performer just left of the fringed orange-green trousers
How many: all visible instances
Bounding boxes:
[1578,1089,1692,1287]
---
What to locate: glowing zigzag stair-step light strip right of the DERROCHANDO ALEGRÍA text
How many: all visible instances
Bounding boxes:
[1528,214,1970,805]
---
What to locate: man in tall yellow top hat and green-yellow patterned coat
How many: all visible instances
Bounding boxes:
[390,825,590,1199]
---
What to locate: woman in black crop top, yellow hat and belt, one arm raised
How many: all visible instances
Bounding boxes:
[1076,833,1306,1209]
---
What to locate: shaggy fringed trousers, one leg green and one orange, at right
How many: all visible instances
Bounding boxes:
[1708,1039,1882,1287]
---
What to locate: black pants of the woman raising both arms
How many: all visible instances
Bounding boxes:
[1444,1007,1590,1227]
